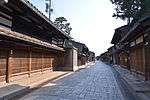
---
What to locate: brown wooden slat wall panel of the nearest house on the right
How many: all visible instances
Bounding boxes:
[130,47,145,73]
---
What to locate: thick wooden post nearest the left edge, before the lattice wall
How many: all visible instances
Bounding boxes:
[6,50,13,83]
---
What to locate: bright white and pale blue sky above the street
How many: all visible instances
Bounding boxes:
[29,0,126,55]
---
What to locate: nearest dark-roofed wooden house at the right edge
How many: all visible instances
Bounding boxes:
[122,16,150,80]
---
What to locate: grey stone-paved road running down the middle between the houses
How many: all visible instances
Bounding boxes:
[20,62,124,100]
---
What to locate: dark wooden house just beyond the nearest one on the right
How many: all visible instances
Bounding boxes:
[108,25,130,69]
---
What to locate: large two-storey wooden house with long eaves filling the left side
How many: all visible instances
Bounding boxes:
[0,0,70,82]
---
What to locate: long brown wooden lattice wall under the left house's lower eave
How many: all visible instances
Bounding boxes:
[0,46,63,81]
